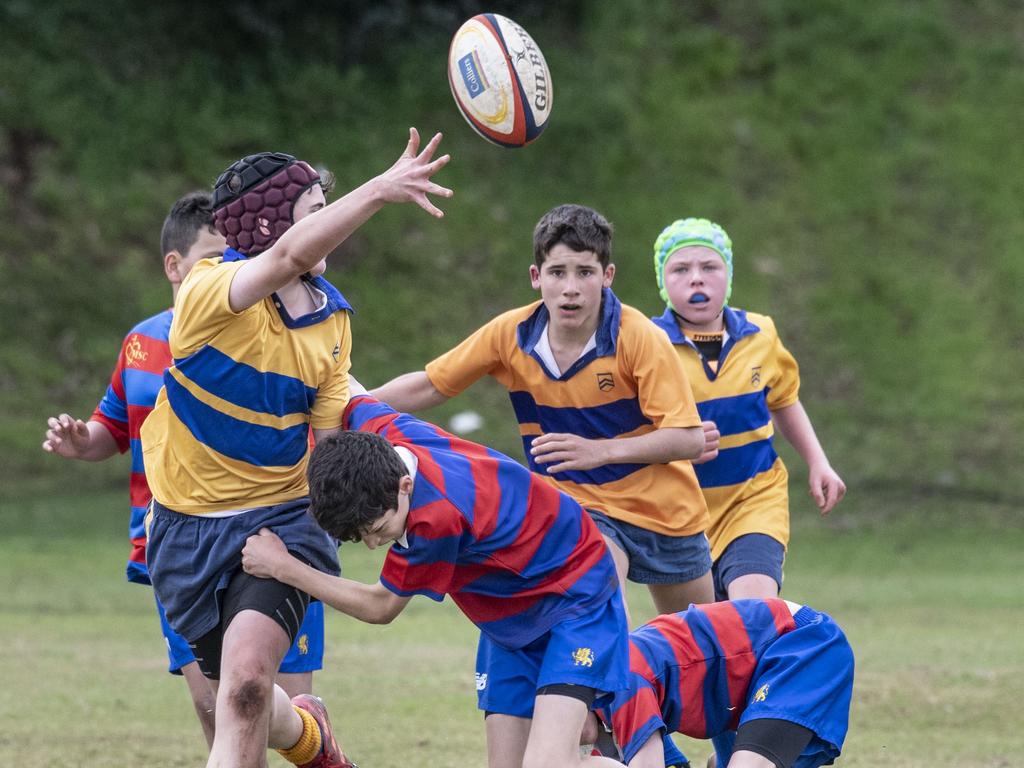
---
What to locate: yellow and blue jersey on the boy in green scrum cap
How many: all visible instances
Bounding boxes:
[653,306,800,559]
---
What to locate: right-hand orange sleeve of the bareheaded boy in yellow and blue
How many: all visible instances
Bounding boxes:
[626,317,700,429]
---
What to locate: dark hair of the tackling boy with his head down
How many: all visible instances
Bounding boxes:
[307,431,409,542]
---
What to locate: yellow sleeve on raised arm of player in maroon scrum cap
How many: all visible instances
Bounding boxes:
[170,259,248,359]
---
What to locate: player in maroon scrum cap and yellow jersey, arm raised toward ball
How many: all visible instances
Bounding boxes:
[142,129,451,768]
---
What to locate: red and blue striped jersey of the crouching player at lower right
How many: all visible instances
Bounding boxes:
[611,599,796,762]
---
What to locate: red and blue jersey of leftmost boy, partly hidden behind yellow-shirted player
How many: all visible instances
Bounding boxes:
[91,309,173,584]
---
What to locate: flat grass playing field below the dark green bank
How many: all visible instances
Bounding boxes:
[0,490,1024,768]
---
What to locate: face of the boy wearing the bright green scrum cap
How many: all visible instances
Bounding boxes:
[665,246,729,330]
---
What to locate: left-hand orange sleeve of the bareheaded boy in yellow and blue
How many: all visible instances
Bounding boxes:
[426,313,515,397]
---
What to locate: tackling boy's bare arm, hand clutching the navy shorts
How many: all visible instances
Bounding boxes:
[242,528,412,624]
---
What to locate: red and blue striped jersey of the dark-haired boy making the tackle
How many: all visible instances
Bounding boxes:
[345,396,618,648]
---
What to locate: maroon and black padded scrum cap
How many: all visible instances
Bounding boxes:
[213,152,321,256]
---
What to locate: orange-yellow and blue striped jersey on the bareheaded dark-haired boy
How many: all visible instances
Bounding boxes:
[426,289,708,536]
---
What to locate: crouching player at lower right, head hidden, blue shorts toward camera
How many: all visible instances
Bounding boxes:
[585,598,853,768]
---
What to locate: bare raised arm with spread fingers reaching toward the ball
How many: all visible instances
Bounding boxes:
[228,128,453,312]
